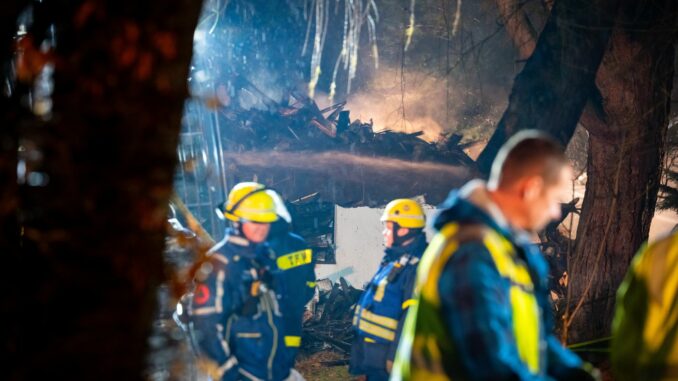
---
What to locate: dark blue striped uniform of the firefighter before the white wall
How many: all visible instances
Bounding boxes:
[350,233,427,374]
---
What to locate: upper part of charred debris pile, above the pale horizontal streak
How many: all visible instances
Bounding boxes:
[218,85,473,161]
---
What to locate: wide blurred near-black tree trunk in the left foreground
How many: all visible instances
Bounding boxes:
[0,0,201,380]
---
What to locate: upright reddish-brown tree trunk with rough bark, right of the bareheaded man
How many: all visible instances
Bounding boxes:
[563,0,678,343]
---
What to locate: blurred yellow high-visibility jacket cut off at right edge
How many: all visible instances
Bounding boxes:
[611,230,678,381]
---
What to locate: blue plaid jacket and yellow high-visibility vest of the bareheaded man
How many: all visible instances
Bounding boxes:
[391,182,592,381]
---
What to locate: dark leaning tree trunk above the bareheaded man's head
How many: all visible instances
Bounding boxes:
[477,0,621,173]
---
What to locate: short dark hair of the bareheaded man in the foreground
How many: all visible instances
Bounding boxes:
[488,130,569,189]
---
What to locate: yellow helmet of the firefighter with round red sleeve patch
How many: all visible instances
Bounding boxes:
[224,182,278,224]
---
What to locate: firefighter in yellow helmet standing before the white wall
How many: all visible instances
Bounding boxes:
[350,199,427,381]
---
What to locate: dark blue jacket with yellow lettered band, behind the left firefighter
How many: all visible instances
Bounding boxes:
[268,219,315,368]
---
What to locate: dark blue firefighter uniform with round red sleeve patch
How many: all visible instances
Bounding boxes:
[188,229,290,381]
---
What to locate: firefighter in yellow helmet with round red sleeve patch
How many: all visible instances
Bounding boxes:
[188,182,298,381]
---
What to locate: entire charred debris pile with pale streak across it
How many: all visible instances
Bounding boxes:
[201,84,474,206]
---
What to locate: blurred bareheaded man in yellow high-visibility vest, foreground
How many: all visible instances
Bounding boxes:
[391,131,593,381]
